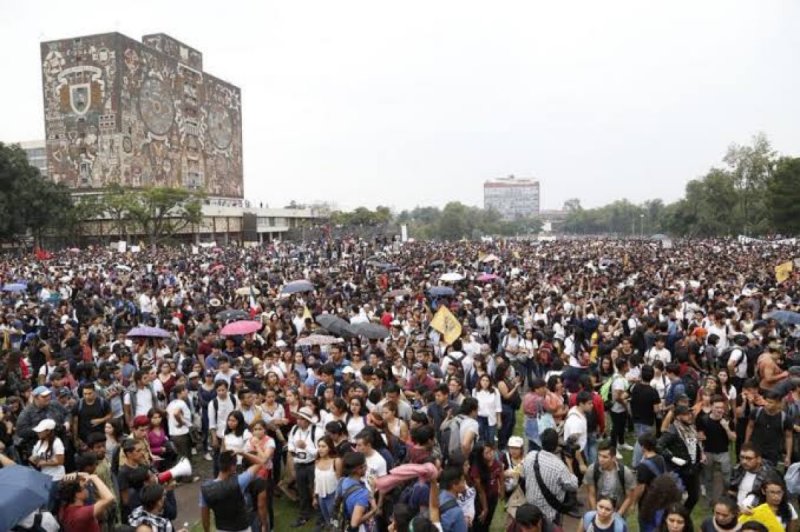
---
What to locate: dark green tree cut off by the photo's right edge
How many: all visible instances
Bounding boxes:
[766,157,800,235]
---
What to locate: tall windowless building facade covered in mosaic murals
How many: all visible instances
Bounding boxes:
[41,33,243,198]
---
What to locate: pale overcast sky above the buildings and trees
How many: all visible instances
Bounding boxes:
[0,0,800,209]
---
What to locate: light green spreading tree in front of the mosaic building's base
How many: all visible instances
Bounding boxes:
[129,187,204,246]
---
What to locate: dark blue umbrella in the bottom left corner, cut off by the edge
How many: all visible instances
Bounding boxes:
[0,465,53,530]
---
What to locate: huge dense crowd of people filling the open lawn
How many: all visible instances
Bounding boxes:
[0,239,800,532]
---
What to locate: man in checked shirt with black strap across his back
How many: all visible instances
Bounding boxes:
[523,428,580,524]
